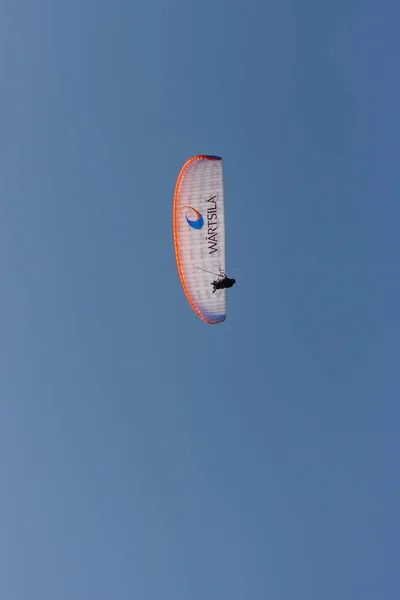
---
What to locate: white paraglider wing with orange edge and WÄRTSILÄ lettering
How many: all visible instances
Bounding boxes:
[174,155,226,325]
